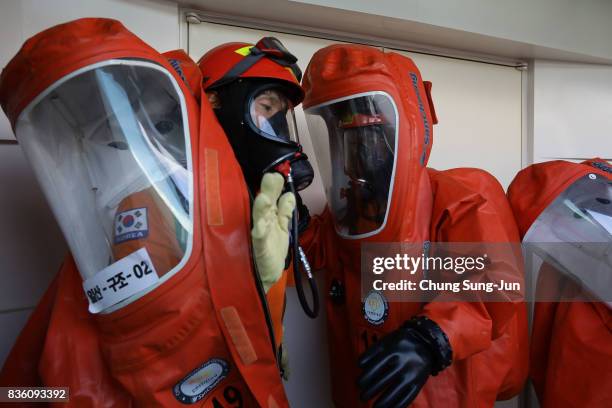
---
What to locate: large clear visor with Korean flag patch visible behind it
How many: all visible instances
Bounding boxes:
[16,60,193,312]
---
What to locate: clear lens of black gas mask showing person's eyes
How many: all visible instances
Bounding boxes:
[248,88,298,142]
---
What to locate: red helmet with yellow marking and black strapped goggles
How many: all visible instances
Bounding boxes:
[198,37,304,105]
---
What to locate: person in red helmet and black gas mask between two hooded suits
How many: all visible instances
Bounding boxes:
[198,37,317,373]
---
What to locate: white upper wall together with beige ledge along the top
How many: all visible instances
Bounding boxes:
[176,0,612,64]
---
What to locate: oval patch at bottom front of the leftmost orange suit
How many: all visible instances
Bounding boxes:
[173,358,229,404]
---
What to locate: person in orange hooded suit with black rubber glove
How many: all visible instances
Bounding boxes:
[302,45,527,408]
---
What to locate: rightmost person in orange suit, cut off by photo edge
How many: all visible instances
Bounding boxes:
[508,159,612,408]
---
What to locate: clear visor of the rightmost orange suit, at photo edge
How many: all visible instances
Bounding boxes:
[524,174,612,302]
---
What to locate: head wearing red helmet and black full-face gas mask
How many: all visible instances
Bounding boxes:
[199,37,314,194]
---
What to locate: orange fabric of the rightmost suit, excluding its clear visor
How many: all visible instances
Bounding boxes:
[508,159,612,408]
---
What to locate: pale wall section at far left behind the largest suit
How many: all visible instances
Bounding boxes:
[0,0,179,366]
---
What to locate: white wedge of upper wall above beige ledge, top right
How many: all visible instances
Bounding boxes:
[295,0,612,59]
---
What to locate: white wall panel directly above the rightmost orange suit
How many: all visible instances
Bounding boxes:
[532,60,612,162]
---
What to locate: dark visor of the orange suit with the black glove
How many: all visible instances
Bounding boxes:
[305,92,397,238]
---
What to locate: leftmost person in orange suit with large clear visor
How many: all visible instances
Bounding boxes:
[0,18,294,408]
